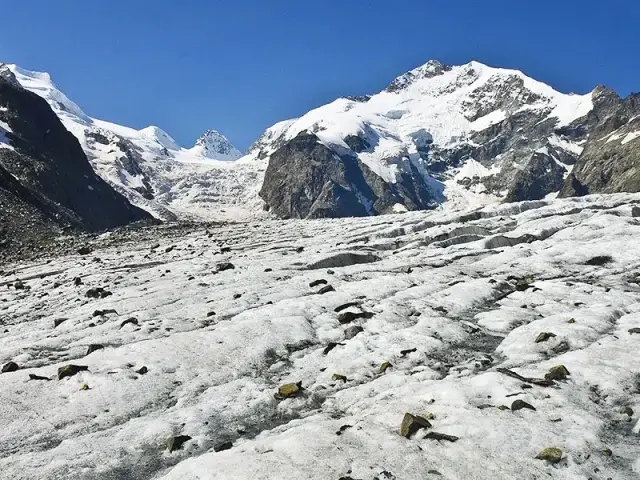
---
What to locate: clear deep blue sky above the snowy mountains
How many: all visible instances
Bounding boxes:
[0,0,640,149]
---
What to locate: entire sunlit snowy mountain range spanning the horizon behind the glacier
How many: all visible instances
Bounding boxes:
[6,61,640,220]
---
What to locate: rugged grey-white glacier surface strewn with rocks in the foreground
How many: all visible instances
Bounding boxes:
[0,195,640,480]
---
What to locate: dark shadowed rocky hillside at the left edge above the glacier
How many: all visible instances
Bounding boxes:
[0,72,150,255]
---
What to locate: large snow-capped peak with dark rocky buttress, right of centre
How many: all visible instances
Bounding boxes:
[257,61,593,218]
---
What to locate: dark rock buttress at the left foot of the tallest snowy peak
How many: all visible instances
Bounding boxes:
[260,132,435,218]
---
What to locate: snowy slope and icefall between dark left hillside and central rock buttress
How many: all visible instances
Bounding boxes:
[5,65,264,220]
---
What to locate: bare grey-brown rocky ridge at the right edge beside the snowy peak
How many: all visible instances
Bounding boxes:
[559,88,640,197]
